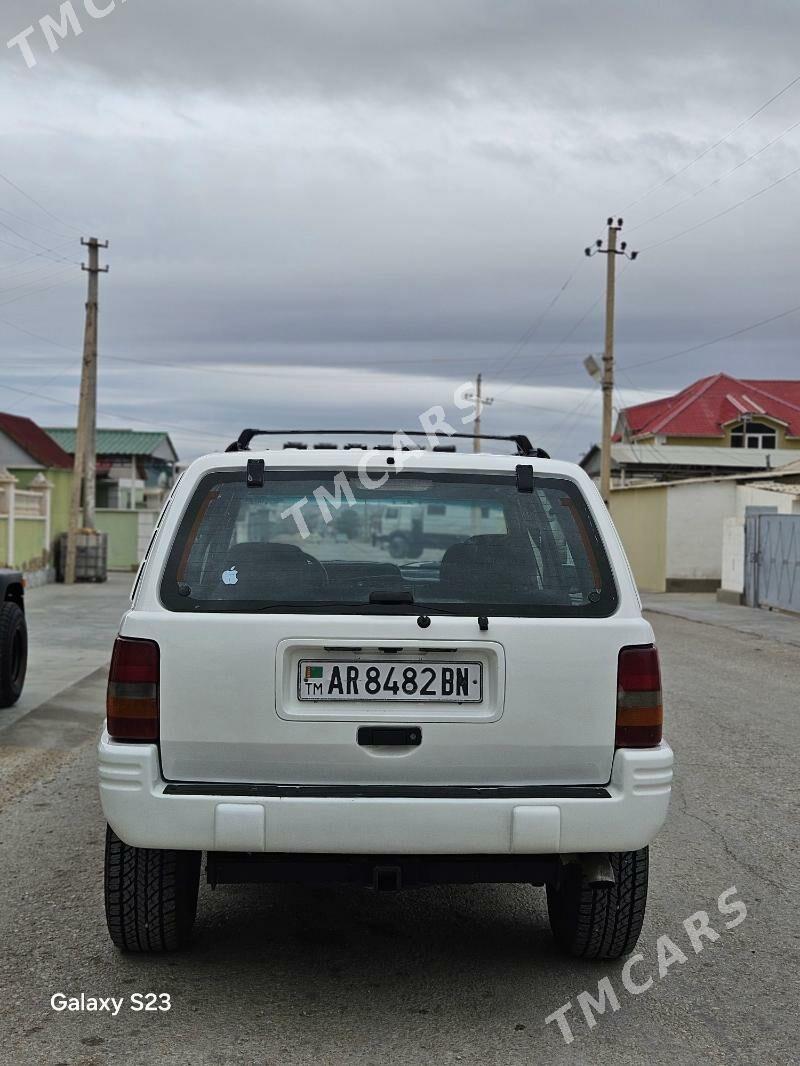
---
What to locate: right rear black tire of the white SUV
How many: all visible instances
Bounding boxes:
[547,847,650,958]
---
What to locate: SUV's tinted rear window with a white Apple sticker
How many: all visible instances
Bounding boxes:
[161,469,617,617]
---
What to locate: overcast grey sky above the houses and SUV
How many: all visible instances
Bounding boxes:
[0,0,800,458]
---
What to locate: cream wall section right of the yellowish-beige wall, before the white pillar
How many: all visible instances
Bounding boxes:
[667,481,736,592]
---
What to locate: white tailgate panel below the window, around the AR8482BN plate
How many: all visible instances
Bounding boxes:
[123,611,653,785]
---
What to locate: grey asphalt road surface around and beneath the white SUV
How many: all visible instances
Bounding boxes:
[0,615,800,1066]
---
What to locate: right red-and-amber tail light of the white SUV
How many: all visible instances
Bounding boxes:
[614,645,663,747]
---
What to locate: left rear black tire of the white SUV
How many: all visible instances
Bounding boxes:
[106,826,202,952]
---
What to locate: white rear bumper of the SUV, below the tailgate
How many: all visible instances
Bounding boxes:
[98,732,673,855]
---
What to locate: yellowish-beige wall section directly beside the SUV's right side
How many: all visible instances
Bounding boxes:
[610,486,669,593]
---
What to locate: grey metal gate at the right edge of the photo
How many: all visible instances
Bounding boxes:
[745,514,800,613]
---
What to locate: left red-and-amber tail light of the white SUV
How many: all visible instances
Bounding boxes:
[106,636,159,741]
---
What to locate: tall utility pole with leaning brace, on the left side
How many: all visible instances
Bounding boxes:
[64,237,109,585]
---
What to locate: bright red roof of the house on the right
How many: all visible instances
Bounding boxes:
[622,374,800,437]
